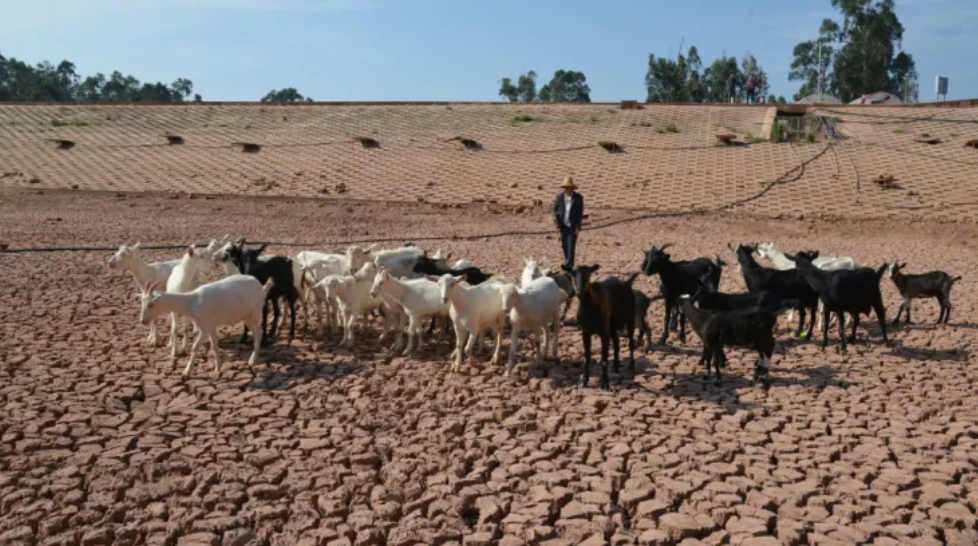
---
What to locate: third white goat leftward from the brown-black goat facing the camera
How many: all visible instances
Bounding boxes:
[370,269,449,355]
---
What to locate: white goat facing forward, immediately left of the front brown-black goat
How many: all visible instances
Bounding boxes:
[502,277,560,375]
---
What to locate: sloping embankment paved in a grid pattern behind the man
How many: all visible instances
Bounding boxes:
[0,104,978,218]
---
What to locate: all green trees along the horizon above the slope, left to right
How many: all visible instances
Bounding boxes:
[0,0,919,103]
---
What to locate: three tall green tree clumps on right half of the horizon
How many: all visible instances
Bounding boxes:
[499,0,919,104]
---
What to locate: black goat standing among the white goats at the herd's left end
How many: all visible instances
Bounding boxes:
[226,239,299,345]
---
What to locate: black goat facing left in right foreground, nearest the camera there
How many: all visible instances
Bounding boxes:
[682,295,778,389]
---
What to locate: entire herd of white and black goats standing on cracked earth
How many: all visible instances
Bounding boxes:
[109,236,961,389]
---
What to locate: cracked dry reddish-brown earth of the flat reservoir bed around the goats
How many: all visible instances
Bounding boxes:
[0,191,978,546]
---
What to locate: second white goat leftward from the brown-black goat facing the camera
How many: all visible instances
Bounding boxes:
[436,274,506,372]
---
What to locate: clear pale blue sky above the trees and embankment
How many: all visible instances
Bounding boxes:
[0,0,978,102]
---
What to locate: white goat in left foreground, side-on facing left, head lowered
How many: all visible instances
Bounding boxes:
[140,275,267,377]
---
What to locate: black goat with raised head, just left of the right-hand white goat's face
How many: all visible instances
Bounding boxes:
[728,245,818,338]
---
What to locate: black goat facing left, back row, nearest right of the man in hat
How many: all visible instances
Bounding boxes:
[642,244,723,345]
